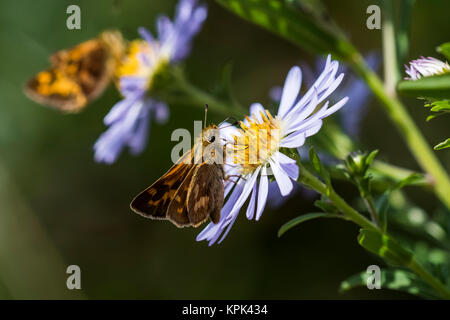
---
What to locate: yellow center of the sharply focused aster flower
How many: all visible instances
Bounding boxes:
[226,110,283,175]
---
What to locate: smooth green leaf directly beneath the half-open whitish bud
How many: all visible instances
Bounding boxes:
[397,74,450,99]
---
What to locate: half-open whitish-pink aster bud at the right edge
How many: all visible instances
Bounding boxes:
[405,57,450,80]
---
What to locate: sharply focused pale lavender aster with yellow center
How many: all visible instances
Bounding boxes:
[197,56,348,245]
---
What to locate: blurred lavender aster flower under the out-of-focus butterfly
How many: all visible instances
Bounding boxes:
[94,0,207,163]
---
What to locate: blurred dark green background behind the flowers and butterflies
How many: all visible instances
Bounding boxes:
[0,0,450,299]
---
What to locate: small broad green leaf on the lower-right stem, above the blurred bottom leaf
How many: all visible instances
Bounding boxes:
[358,229,413,266]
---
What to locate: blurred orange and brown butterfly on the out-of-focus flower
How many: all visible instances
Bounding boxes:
[24,30,125,113]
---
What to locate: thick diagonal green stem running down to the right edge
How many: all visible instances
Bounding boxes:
[350,54,450,208]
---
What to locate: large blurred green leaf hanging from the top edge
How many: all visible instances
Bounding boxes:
[216,0,356,61]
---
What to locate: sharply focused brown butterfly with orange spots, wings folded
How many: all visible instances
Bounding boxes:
[130,107,225,228]
